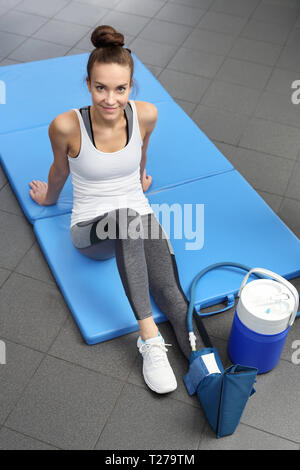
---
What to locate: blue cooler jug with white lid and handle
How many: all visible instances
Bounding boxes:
[228,268,299,374]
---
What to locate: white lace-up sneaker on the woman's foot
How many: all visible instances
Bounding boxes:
[137,333,177,393]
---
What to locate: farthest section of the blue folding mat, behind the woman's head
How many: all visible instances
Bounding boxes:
[0,53,173,134]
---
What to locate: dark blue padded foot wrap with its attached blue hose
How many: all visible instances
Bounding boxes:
[183,262,258,438]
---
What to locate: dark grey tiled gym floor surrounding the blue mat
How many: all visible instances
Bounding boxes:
[0,0,300,450]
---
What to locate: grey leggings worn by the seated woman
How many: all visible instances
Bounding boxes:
[70,208,202,359]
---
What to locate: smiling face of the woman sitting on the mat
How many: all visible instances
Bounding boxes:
[87,62,132,121]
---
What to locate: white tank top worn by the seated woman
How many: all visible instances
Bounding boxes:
[68,100,153,227]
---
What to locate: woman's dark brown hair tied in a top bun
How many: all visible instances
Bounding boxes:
[87,25,134,94]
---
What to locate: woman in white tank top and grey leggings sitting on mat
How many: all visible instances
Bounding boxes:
[30,25,200,393]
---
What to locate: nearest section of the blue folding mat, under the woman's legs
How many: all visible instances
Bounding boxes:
[34,170,300,344]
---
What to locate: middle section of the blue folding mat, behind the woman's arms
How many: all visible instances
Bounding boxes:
[0,101,233,223]
